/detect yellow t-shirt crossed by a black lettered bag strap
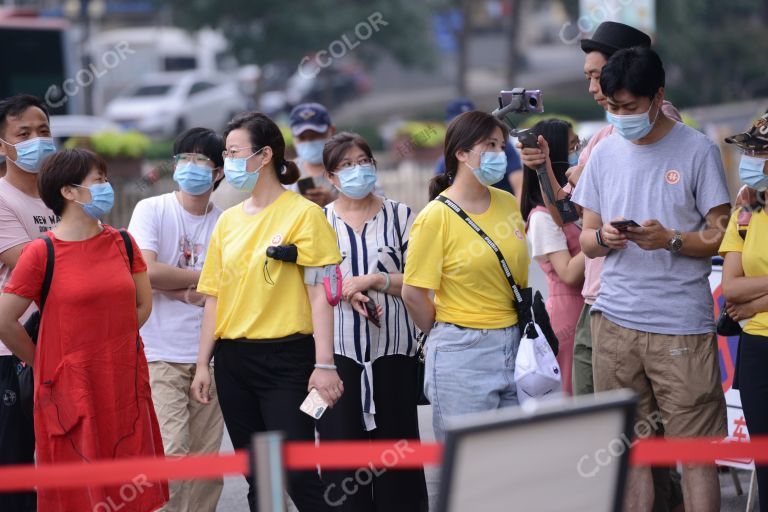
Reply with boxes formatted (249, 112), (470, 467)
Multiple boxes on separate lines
(404, 187), (530, 329)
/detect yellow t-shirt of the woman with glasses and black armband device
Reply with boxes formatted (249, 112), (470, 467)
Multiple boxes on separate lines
(197, 191), (341, 340)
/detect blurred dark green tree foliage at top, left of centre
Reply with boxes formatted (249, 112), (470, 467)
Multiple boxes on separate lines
(156, 0), (433, 66)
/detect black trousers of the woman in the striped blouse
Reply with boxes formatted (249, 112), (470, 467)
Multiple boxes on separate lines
(317, 354), (427, 512)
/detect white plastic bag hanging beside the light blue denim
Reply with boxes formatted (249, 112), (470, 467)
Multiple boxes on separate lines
(515, 323), (563, 404)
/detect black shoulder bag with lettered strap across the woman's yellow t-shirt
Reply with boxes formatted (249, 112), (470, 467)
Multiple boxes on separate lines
(437, 195), (560, 355)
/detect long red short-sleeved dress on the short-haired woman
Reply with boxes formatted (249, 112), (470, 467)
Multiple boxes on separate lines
(4, 225), (168, 512)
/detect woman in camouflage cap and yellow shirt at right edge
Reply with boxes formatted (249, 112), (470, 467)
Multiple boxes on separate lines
(720, 121), (768, 512)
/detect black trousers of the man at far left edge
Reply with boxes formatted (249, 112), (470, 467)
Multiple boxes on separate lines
(0, 356), (37, 512)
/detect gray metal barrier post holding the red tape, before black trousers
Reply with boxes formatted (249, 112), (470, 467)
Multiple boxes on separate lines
(251, 432), (287, 512)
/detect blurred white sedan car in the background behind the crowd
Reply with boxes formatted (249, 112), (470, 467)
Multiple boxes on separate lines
(105, 72), (248, 138)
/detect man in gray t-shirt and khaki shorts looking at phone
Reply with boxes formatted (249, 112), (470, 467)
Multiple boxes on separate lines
(573, 48), (730, 511)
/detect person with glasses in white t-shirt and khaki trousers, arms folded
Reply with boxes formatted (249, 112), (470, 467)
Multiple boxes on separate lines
(129, 128), (224, 512)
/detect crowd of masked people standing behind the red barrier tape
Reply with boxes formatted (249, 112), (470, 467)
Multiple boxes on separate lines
(0, 18), (768, 512)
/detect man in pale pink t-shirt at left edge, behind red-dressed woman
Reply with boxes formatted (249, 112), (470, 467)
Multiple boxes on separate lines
(0, 95), (59, 511)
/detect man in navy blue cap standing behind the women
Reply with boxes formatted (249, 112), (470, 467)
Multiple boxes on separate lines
(286, 103), (338, 206)
